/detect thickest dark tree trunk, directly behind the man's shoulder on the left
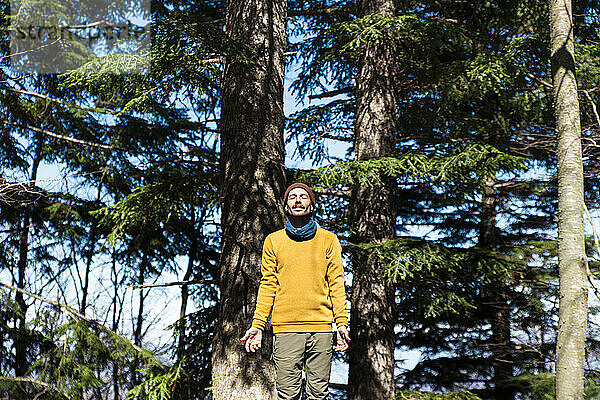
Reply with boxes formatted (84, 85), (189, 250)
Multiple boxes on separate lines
(212, 0), (286, 400)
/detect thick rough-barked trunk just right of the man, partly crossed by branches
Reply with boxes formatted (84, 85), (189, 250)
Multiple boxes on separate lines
(348, 0), (396, 400)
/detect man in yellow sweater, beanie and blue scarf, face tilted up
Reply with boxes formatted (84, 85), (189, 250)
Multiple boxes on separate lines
(241, 183), (350, 400)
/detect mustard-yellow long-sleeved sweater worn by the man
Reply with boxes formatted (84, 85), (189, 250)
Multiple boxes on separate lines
(252, 228), (348, 333)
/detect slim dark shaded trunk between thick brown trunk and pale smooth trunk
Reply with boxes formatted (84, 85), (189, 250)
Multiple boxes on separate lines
(477, 176), (515, 400)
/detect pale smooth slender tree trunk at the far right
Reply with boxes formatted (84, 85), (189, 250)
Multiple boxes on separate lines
(550, 0), (588, 400)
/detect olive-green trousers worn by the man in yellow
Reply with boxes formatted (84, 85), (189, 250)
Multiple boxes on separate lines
(273, 332), (333, 400)
